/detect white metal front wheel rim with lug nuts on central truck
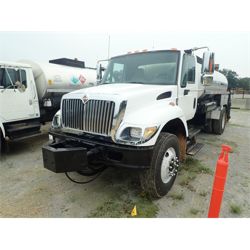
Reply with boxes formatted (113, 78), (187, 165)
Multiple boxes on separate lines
(161, 148), (178, 184)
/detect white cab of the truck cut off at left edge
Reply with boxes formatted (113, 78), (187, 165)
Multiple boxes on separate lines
(0, 62), (40, 146)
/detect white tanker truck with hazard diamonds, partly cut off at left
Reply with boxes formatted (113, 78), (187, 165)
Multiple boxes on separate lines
(0, 58), (96, 152)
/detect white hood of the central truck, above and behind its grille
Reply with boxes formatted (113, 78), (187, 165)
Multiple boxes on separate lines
(63, 83), (177, 128)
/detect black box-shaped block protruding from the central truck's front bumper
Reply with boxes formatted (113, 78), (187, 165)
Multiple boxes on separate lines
(42, 143), (88, 173)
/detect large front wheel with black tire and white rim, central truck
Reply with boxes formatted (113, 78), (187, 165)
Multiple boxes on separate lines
(140, 133), (180, 198)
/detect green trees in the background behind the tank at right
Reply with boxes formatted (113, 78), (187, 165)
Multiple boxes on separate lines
(219, 69), (250, 91)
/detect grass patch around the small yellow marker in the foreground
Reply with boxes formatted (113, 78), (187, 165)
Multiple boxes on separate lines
(89, 196), (158, 218)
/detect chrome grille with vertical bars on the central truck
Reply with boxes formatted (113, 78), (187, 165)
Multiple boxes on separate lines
(62, 99), (115, 135)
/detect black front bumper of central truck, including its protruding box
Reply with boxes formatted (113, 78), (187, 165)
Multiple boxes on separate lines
(42, 131), (153, 173)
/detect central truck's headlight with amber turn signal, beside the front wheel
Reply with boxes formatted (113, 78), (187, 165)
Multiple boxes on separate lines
(120, 126), (158, 144)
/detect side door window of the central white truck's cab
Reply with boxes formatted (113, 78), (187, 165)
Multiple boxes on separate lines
(181, 54), (195, 88)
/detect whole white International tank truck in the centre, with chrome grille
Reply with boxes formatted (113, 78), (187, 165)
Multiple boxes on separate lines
(43, 48), (231, 197)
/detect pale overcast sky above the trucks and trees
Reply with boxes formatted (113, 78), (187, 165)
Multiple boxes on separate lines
(0, 32), (250, 77)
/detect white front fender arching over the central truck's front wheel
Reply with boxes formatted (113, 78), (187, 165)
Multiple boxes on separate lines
(117, 102), (188, 146)
